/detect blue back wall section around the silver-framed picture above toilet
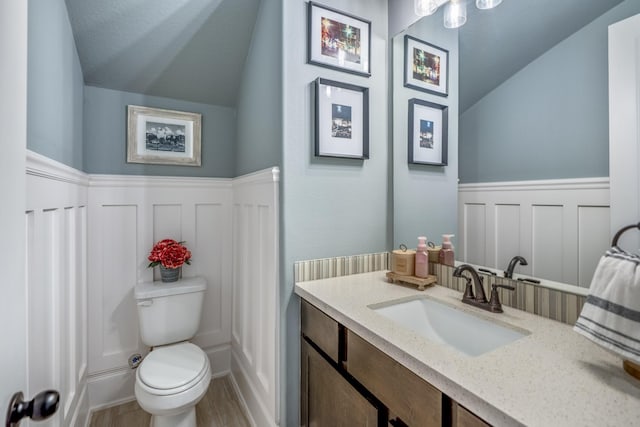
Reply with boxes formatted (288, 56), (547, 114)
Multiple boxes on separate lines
(84, 86), (236, 178)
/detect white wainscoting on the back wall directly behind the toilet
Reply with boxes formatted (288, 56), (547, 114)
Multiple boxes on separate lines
(88, 175), (232, 408)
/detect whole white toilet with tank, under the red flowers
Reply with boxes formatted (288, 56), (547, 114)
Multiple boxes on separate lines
(135, 277), (211, 427)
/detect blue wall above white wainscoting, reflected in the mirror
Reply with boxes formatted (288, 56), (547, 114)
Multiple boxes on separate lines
(459, 0), (640, 183)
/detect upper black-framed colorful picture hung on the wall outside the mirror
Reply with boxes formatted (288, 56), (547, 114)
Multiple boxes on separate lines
(307, 2), (371, 77)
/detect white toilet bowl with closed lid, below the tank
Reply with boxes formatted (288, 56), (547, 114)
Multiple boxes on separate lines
(135, 342), (211, 427)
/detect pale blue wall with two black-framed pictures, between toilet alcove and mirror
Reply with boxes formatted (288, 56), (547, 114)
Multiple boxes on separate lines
(280, 0), (391, 426)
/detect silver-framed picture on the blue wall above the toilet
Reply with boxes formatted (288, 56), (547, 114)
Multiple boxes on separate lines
(127, 105), (202, 166)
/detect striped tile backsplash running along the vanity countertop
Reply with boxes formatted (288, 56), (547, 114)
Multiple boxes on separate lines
(293, 252), (586, 325)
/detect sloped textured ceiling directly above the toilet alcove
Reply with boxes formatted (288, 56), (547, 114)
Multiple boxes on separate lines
(66, 0), (260, 106)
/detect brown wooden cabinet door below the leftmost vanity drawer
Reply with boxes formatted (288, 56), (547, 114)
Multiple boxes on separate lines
(300, 339), (378, 427)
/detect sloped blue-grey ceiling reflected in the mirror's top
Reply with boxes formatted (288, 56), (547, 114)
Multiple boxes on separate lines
(458, 0), (622, 112)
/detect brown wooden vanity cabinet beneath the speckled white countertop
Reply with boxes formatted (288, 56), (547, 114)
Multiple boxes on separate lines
(300, 300), (489, 427)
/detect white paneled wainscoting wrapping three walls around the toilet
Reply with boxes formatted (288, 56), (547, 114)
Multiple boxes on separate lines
(25, 152), (279, 426)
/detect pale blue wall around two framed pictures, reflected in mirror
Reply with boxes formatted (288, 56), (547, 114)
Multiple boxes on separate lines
(392, 12), (459, 248)
